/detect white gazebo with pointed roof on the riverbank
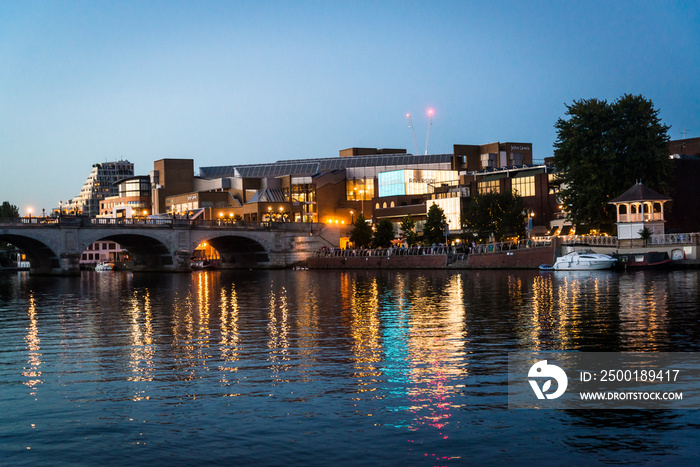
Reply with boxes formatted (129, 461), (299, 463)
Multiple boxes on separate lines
(608, 183), (671, 240)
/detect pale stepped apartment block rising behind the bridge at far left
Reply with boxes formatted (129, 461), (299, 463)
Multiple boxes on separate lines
(61, 160), (134, 217)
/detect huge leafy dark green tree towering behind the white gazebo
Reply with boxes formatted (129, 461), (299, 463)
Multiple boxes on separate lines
(554, 94), (671, 231)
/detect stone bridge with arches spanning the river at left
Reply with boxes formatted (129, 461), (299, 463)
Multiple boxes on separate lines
(0, 217), (337, 275)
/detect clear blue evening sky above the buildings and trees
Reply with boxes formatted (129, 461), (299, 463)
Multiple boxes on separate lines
(0, 0), (700, 214)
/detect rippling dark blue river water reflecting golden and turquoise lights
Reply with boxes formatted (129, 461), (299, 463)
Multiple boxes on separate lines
(0, 271), (700, 465)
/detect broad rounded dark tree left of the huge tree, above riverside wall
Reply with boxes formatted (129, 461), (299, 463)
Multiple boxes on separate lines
(462, 191), (526, 241)
